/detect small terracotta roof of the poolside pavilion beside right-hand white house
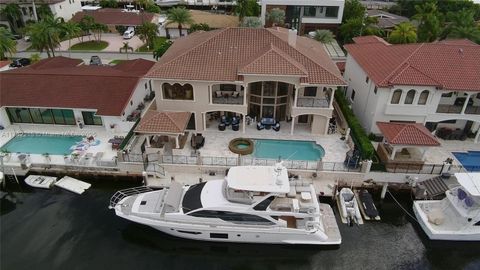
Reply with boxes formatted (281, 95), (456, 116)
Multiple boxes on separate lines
(377, 122), (440, 146)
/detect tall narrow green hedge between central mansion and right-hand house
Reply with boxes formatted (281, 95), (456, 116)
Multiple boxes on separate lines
(335, 91), (375, 159)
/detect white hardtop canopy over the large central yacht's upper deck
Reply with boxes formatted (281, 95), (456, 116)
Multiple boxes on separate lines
(226, 164), (290, 193)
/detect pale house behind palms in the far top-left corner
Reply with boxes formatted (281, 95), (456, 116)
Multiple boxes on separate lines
(0, 0), (82, 22)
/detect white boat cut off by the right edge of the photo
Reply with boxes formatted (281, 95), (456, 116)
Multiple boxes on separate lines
(413, 173), (480, 241)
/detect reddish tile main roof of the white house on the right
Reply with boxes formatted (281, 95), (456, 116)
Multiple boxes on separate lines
(345, 37), (480, 91)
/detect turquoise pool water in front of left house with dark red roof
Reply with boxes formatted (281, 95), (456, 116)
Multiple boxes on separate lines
(0, 134), (83, 155)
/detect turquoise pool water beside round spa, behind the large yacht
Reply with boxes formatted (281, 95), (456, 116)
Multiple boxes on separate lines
(253, 139), (325, 160)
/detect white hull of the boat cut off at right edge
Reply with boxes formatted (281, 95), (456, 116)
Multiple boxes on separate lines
(413, 201), (480, 241)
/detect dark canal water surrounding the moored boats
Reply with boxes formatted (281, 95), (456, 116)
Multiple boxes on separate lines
(0, 179), (480, 270)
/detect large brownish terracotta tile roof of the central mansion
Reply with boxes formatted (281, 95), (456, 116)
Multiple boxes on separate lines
(147, 28), (346, 85)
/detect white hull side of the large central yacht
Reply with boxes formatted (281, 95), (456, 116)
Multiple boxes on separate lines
(115, 206), (341, 245)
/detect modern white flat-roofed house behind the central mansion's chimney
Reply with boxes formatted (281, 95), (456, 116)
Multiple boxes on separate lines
(260, 0), (345, 35)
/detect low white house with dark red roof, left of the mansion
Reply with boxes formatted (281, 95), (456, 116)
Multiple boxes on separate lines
(0, 57), (154, 132)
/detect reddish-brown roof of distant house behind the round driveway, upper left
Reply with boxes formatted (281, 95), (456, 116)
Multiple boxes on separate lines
(71, 8), (155, 26)
